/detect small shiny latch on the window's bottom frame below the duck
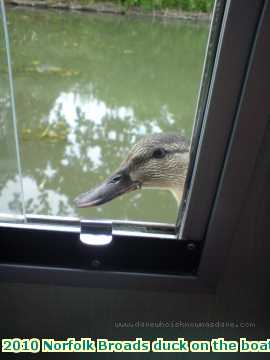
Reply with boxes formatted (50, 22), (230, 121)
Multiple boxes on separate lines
(80, 220), (112, 246)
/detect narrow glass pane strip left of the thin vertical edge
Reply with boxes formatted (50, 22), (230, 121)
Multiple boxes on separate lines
(0, 2), (23, 220)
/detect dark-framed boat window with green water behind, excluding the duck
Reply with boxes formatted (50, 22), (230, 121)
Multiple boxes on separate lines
(0, 0), (270, 290)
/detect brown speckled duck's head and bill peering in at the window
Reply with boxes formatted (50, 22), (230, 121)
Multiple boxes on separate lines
(74, 133), (190, 208)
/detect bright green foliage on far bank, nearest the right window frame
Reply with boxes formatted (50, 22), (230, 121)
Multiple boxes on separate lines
(120, 0), (214, 12)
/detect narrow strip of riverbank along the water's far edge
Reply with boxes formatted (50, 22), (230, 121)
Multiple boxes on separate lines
(5, 0), (211, 21)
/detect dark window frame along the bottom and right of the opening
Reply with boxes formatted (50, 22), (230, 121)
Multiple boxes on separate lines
(0, 0), (270, 292)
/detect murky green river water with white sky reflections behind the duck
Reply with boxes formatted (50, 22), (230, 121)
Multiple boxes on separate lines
(0, 9), (209, 223)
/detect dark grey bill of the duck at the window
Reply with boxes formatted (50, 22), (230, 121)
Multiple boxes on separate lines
(74, 174), (140, 208)
